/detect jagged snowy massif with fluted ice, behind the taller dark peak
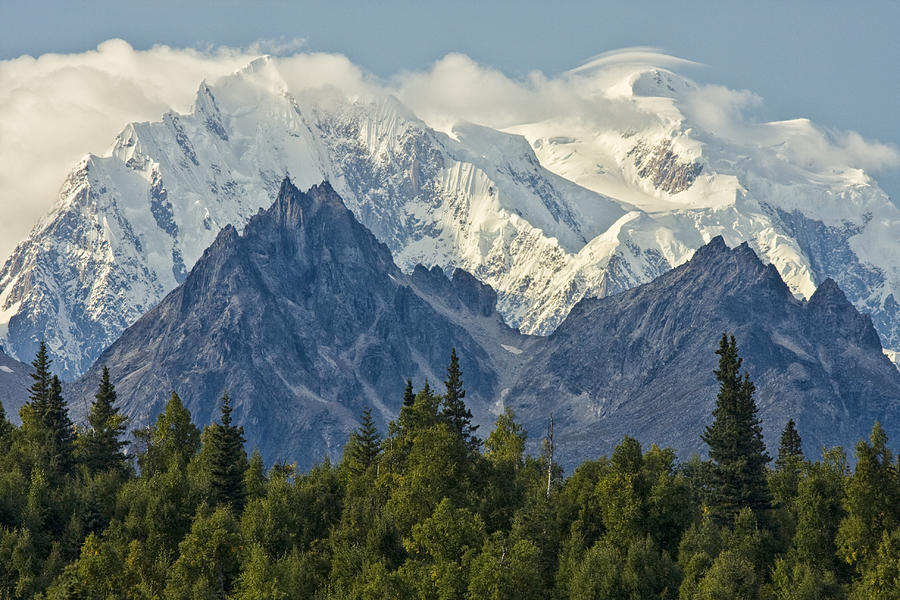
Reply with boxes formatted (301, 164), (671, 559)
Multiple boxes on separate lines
(0, 59), (626, 380)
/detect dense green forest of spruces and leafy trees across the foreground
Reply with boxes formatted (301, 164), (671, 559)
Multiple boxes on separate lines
(0, 335), (900, 600)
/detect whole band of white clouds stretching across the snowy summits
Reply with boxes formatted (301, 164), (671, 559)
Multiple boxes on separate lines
(0, 40), (900, 257)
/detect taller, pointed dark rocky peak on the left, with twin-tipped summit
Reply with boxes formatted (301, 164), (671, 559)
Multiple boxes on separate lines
(70, 181), (517, 466)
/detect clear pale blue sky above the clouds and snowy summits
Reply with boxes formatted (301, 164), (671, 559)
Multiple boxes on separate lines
(0, 0), (900, 201)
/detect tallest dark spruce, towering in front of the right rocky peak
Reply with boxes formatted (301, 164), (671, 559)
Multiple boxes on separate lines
(702, 333), (771, 524)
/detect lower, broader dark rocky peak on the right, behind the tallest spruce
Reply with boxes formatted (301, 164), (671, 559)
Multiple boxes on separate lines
(507, 238), (900, 462)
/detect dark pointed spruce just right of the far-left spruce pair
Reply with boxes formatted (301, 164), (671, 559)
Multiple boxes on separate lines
(78, 367), (127, 473)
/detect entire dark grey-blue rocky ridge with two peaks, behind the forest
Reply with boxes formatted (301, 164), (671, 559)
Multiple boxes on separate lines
(69, 180), (900, 466)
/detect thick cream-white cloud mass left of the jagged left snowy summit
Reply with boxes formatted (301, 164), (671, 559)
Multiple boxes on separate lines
(0, 40), (268, 256)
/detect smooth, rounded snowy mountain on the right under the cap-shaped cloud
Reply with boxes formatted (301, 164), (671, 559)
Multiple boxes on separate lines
(509, 65), (900, 348)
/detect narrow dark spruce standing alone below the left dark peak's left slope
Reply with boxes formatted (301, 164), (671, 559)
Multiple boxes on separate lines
(210, 393), (247, 513)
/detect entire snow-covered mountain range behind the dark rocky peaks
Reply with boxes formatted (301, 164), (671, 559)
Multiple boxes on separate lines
(0, 58), (900, 378)
